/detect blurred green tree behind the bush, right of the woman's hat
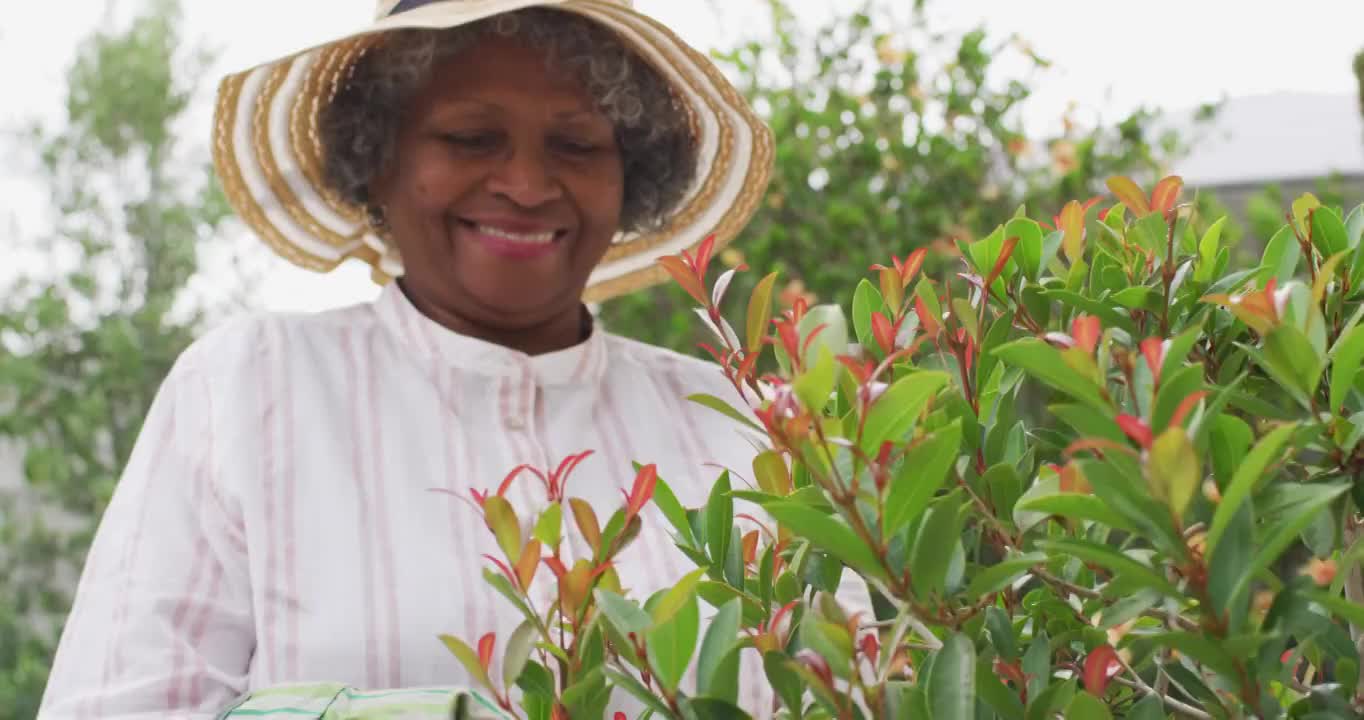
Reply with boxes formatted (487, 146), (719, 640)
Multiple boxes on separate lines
(603, 0), (1211, 352)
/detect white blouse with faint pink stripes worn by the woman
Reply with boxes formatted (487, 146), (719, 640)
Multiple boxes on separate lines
(41, 285), (780, 719)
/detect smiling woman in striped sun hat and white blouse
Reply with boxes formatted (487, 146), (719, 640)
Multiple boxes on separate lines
(42, 0), (771, 719)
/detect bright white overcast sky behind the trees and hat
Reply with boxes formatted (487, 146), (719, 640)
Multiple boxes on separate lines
(0, 0), (1364, 308)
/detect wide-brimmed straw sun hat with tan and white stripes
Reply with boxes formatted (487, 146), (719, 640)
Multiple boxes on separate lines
(213, 0), (772, 301)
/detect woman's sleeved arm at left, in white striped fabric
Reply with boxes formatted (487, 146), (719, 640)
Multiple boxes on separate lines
(40, 349), (254, 720)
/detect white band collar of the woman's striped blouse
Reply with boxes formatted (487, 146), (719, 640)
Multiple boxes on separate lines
(375, 282), (607, 386)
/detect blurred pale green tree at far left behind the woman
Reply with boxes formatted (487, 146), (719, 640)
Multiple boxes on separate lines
(0, 0), (228, 720)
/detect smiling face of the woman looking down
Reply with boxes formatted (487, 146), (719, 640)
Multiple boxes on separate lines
(371, 38), (623, 340)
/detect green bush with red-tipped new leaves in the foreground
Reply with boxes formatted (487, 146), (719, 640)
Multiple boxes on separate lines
(446, 177), (1364, 720)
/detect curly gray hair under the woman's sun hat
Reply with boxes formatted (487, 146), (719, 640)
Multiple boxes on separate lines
(319, 8), (697, 232)
